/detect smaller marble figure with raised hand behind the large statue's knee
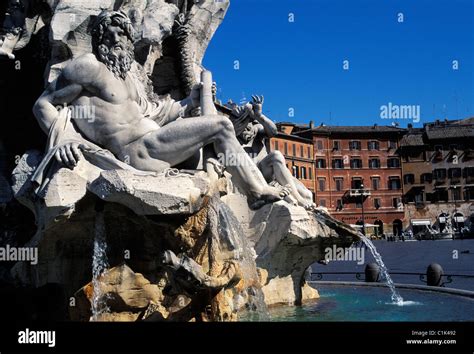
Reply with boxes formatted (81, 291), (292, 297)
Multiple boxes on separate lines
(230, 95), (315, 210)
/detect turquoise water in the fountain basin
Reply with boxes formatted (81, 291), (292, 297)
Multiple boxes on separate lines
(262, 285), (474, 322)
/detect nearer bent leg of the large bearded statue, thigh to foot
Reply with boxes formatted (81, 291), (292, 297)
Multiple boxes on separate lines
(127, 116), (287, 201)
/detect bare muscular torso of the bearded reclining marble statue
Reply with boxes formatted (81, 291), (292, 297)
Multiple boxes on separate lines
(71, 59), (159, 154)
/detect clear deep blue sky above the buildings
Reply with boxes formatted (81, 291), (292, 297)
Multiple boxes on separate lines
(204, 0), (474, 126)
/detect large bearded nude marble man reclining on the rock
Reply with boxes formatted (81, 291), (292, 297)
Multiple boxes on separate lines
(33, 11), (289, 202)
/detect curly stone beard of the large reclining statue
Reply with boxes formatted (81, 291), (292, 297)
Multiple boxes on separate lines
(97, 44), (135, 79)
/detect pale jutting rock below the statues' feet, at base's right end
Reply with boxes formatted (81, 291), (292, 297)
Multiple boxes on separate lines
(239, 202), (355, 305)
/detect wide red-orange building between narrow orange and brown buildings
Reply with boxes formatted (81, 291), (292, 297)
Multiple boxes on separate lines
(292, 125), (405, 234)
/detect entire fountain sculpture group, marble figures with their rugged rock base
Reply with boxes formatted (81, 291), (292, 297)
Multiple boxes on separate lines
(0, 0), (358, 321)
